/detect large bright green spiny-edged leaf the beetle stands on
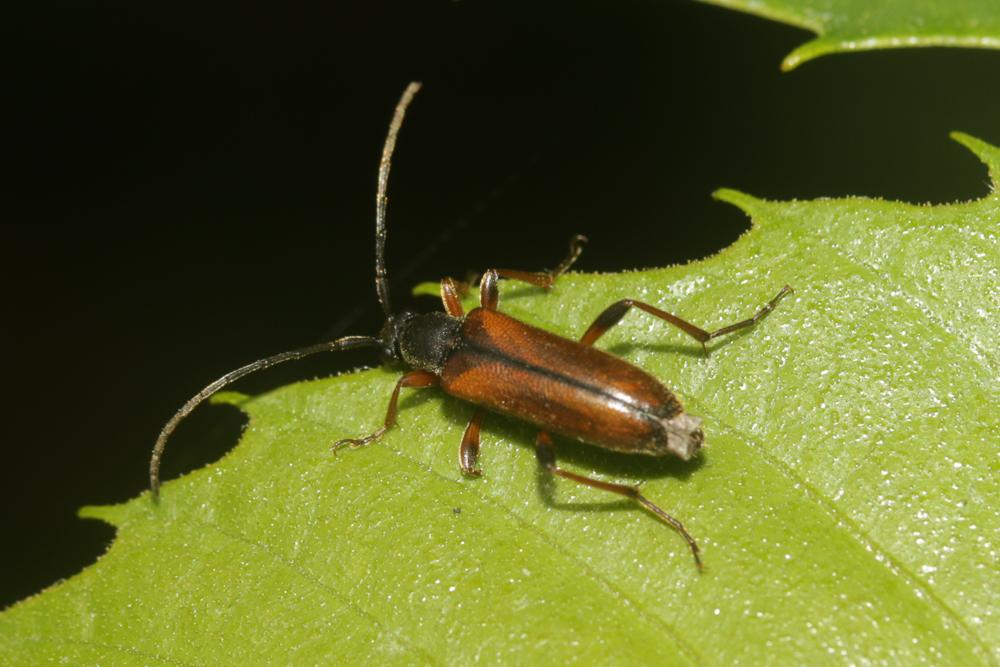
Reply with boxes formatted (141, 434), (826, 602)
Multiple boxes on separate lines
(0, 135), (1000, 665)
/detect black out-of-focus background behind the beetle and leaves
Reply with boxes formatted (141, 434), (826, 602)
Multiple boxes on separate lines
(0, 0), (1000, 606)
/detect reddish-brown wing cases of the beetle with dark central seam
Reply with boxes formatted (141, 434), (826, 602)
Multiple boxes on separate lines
(441, 308), (700, 458)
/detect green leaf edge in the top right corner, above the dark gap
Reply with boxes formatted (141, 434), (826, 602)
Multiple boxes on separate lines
(701, 0), (1000, 70)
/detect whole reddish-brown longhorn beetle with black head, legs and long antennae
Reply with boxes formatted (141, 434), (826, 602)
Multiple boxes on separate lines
(149, 83), (792, 569)
